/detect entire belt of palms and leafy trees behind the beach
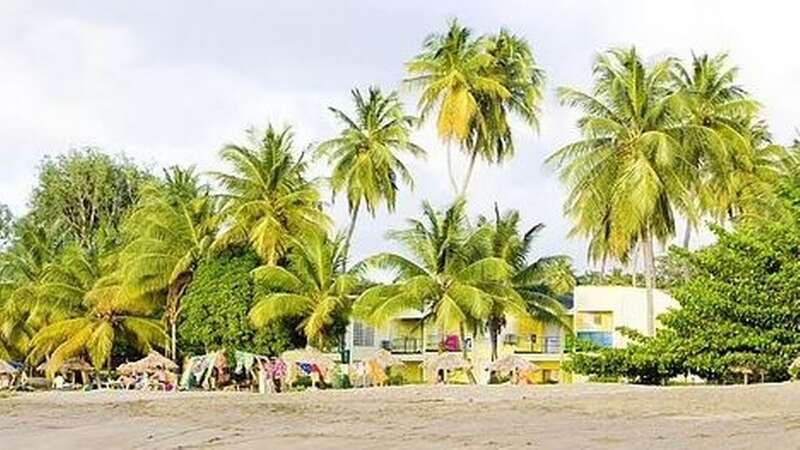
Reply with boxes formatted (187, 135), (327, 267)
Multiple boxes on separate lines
(0, 21), (800, 382)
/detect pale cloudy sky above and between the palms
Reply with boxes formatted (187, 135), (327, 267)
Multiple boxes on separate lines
(0, 0), (800, 268)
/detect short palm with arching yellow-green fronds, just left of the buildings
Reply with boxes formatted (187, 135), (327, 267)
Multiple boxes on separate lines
(250, 233), (358, 347)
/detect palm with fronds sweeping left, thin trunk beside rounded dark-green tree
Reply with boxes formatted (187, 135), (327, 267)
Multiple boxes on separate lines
(121, 168), (219, 359)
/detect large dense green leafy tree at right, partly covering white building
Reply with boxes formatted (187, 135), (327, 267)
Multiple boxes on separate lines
(571, 188), (800, 383)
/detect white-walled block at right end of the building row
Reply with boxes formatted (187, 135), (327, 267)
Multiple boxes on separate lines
(570, 286), (679, 348)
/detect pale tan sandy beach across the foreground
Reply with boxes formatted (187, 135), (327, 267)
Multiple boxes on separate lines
(0, 383), (800, 450)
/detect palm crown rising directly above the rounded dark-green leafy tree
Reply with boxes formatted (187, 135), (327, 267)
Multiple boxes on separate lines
(213, 125), (330, 265)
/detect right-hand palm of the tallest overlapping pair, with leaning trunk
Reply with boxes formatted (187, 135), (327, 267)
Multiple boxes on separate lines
(461, 29), (544, 196)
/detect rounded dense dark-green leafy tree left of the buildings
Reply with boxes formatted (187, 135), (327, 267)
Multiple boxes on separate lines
(178, 250), (305, 355)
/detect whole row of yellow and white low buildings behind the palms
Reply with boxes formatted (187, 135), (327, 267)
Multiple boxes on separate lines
(346, 286), (678, 383)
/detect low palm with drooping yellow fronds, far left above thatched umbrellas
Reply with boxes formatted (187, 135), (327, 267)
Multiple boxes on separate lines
(28, 276), (168, 376)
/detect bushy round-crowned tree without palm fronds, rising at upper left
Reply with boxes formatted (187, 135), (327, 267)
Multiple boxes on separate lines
(30, 148), (152, 249)
